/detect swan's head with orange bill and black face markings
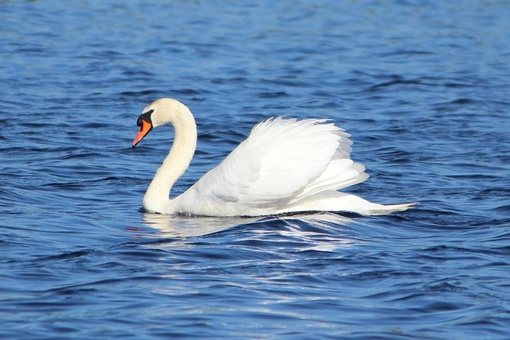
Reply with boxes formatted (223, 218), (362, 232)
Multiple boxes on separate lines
(133, 98), (194, 147)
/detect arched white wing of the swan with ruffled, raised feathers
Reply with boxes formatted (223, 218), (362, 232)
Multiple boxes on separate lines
(175, 117), (368, 215)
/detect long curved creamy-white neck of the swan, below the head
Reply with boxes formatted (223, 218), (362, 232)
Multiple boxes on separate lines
(143, 113), (197, 213)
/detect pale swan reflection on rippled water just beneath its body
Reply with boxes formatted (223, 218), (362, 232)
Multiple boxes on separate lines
(142, 213), (353, 237)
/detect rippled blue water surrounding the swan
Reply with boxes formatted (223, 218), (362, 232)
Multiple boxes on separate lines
(0, 0), (510, 339)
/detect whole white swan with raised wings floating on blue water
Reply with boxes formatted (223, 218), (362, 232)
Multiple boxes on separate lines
(133, 98), (413, 216)
